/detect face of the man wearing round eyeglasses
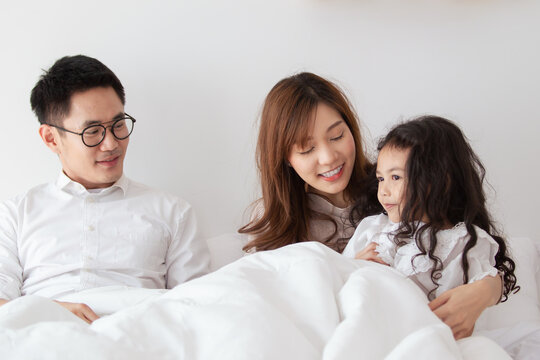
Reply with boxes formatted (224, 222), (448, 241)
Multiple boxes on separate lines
(50, 87), (129, 189)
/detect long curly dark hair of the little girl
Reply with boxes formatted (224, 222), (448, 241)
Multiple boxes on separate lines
(378, 116), (519, 301)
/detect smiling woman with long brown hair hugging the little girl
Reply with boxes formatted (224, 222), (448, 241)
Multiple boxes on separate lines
(239, 73), (502, 339)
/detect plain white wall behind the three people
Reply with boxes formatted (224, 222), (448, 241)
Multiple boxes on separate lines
(0, 0), (540, 239)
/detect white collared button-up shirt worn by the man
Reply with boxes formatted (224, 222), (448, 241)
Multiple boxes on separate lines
(0, 173), (209, 300)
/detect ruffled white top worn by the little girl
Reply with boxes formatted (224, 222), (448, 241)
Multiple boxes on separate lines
(343, 214), (499, 297)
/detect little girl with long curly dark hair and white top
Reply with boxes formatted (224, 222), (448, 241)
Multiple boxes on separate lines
(343, 116), (519, 301)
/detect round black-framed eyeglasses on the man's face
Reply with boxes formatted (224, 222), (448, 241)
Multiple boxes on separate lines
(47, 114), (136, 147)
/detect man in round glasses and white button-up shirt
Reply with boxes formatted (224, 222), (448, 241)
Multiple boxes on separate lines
(0, 55), (209, 323)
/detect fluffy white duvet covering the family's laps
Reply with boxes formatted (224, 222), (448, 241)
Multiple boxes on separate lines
(0, 243), (509, 360)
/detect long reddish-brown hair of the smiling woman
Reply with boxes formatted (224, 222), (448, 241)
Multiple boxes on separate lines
(238, 72), (380, 251)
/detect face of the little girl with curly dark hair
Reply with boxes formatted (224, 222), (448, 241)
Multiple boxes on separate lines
(377, 146), (411, 223)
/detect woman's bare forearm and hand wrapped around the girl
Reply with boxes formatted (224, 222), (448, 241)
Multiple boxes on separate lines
(429, 275), (503, 340)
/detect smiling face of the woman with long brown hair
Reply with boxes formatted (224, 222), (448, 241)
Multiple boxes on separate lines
(288, 103), (356, 207)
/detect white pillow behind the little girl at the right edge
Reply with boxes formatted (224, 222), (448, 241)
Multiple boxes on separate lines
(475, 238), (540, 331)
